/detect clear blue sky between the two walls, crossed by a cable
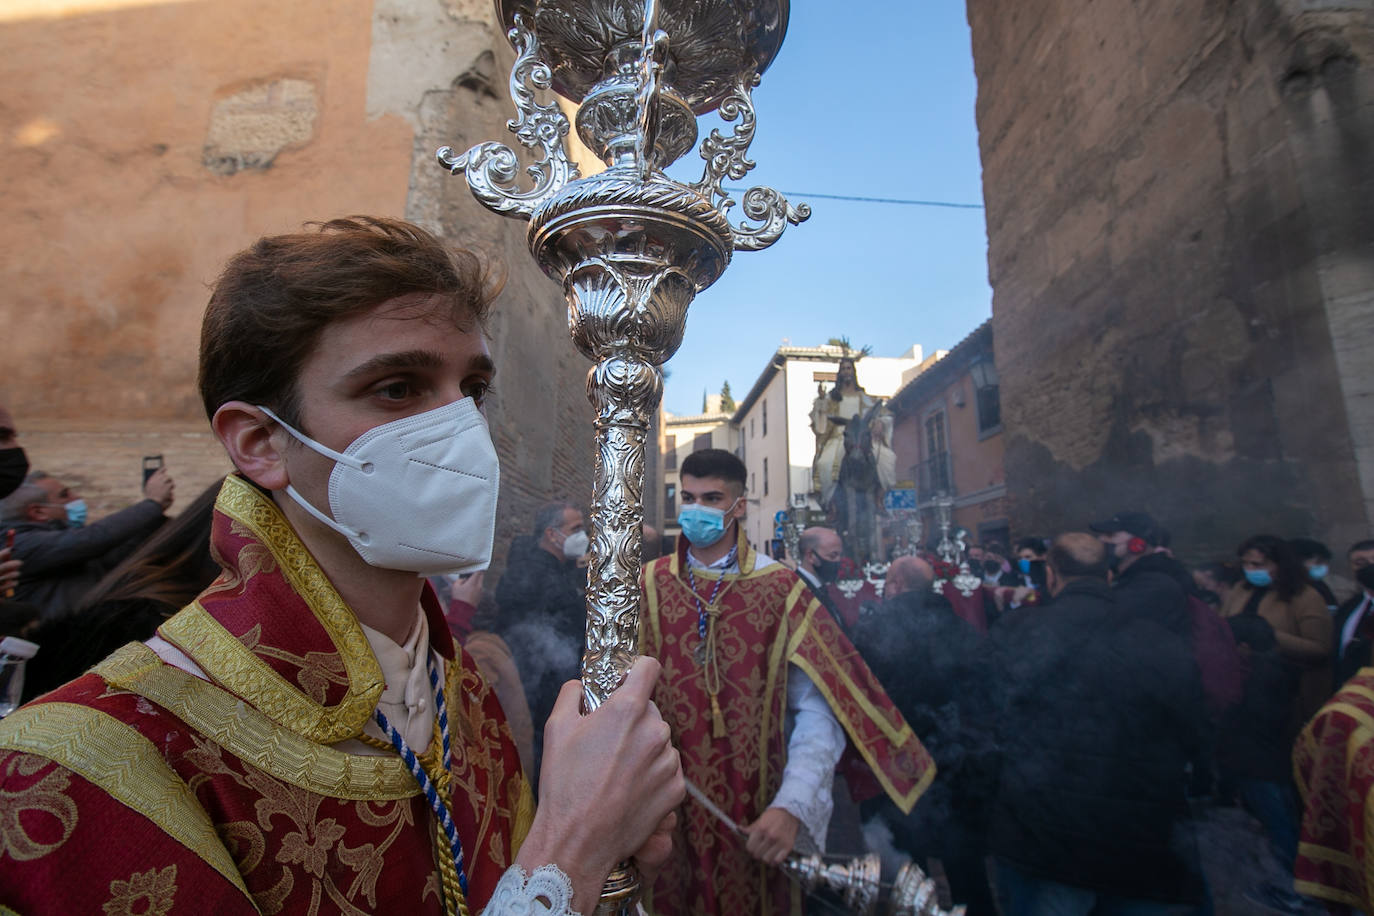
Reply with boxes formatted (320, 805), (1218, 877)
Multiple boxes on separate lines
(664, 0), (992, 413)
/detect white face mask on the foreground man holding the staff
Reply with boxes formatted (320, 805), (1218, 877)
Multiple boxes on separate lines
(258, 398), (500, 575)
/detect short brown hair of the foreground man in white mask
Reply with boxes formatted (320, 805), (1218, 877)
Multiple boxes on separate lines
(199, 216), (502, 424)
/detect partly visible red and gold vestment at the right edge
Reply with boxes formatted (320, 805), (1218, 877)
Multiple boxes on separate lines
(1293, 667), (1374, 912)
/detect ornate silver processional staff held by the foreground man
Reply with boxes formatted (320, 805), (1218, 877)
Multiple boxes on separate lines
(438, 0), (811, 915)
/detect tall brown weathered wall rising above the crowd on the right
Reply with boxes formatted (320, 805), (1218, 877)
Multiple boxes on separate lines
(969, 0), (1374, 558)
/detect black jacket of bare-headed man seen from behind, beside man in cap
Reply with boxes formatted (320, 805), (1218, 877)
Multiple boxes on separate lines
(989, 580), (1204, 902)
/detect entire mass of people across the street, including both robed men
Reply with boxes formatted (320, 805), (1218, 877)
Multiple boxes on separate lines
(0, 218), (1374, 916)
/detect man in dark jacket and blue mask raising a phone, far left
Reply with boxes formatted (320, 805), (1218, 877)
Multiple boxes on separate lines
(0, 468), (174, 619)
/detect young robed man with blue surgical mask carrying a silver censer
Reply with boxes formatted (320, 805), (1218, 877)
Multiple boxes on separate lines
(640, 449), (934, 916)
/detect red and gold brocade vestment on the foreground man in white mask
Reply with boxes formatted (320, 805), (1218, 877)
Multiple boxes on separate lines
(0, 477), (533, 916)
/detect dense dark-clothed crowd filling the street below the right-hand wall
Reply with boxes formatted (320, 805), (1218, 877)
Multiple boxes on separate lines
(801, 511), (1374, 916)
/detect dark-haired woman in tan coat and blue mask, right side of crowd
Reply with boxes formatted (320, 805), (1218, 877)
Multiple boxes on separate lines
(1221, 534), (1334, 737)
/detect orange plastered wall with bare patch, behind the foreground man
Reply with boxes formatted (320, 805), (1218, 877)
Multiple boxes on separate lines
(0, 0), (658, 567)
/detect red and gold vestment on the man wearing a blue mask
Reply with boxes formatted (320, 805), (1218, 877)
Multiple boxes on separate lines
(640, 537), (934, 916)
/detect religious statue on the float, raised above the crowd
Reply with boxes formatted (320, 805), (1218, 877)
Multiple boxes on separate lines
(811, 339), (897, 564)
